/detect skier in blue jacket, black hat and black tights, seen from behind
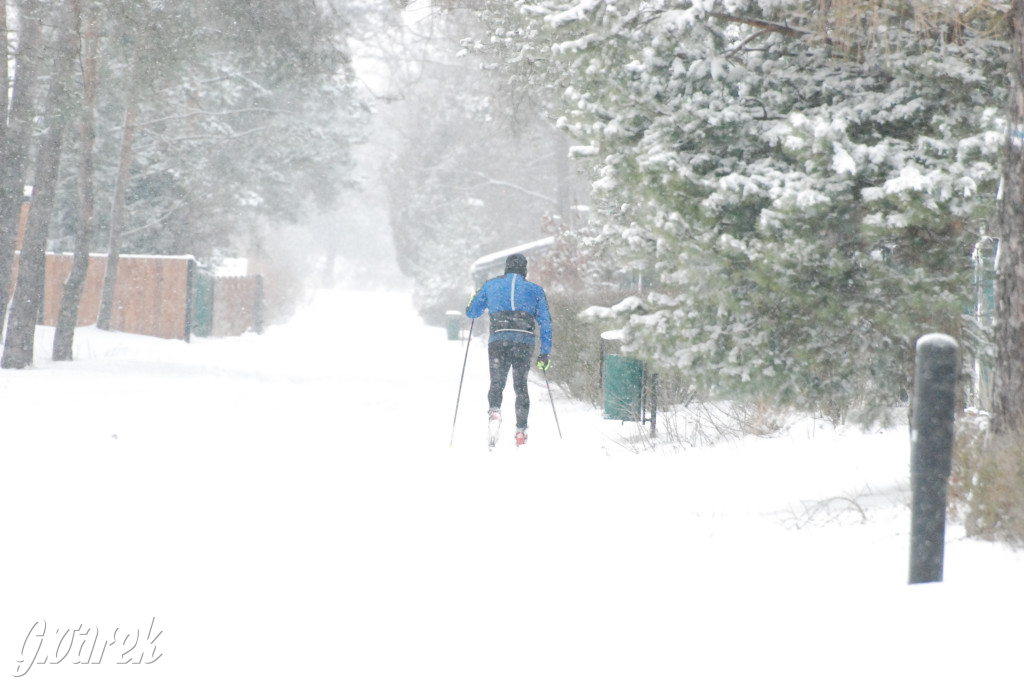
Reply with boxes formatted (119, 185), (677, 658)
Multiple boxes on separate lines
(466, 253), (551, 447)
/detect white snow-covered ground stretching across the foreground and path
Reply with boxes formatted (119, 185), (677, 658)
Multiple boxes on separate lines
(0, 291), (1024, 687)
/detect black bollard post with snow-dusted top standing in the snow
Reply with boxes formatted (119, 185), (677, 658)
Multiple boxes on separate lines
(910, 334), (958, 585)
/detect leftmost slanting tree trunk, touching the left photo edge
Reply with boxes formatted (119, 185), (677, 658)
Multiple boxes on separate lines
(0, 2), (42, 341)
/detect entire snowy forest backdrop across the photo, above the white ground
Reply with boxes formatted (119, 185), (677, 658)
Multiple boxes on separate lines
(0, 0), (1024, 536)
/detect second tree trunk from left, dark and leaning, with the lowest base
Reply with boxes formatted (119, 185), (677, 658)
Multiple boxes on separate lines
(0, 0), (78, 369)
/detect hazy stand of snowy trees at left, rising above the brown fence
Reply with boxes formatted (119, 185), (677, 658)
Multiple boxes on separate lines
(0, 0), (367, 368)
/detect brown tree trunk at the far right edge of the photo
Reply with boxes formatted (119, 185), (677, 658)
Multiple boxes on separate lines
(992, 0), (1024, 433)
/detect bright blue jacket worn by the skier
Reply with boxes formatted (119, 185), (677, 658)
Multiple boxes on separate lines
(466, 272), (551, 354)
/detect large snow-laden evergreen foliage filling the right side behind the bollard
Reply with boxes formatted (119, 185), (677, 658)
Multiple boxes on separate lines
(475, 0), (1007, 422)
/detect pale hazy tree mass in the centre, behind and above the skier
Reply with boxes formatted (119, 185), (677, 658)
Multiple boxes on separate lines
(377, 3), (587, 324)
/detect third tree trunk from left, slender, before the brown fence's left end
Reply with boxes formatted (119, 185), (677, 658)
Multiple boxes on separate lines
(53, 5), (96, 360)
